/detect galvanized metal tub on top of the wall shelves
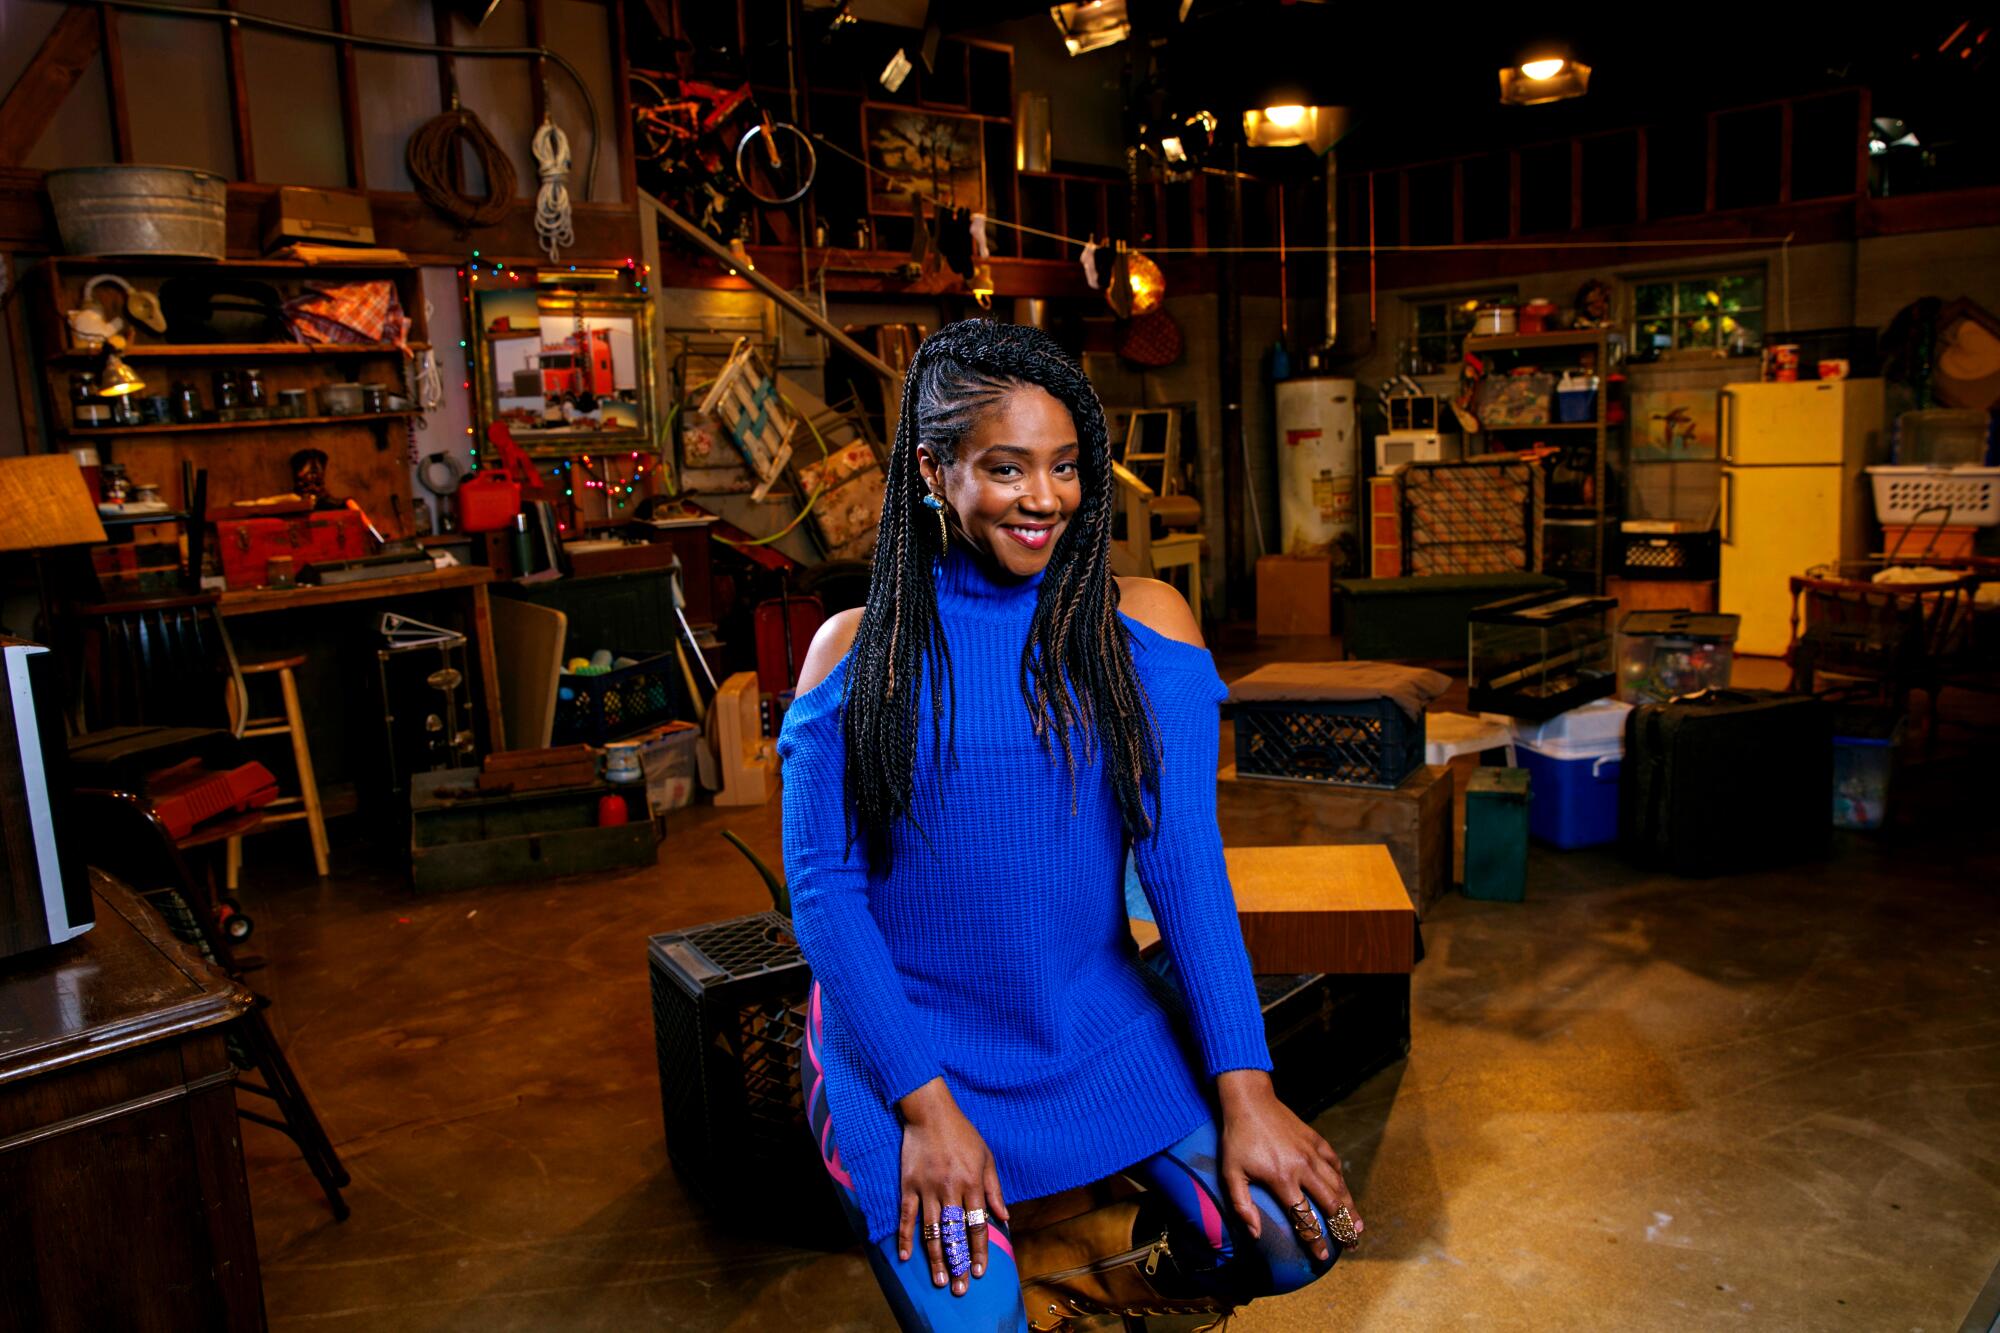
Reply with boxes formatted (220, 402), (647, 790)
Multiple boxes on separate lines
(48, 166), (228, 260)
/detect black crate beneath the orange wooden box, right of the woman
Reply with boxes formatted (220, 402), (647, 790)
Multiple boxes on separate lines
(1144, 949), (1410, 1121)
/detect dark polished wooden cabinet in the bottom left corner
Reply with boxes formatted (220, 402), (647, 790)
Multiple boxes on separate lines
(0, 871), (266, 1333)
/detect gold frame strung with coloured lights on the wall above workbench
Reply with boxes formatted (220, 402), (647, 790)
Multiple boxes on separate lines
(472, 288), (660, 458)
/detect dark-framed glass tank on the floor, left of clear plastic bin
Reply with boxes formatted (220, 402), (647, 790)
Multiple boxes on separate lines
(1468, 592), (1618, 721)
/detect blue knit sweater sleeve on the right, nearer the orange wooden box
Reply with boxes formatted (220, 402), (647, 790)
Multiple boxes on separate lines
(1132, 640), (1270, 1077)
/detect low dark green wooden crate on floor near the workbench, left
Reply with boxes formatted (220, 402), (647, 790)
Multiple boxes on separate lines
(410, 769), (660, 891)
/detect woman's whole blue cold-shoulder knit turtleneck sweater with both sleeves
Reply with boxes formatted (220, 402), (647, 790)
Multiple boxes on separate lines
(778, 548), (1270, 1243)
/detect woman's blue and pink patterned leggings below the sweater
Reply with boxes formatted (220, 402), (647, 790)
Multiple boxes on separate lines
(804, 983), (1340, 1333)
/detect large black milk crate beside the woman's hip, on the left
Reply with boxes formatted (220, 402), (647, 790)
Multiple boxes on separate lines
(646, 913), (850, 1249)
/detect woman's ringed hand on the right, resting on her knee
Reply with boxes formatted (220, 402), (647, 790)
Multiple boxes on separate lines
(1216, 1069), (1362, 1259)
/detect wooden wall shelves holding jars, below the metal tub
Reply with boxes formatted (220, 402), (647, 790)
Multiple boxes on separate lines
(26, 256), (430, 536)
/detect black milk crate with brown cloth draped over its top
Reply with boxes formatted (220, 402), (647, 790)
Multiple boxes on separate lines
(1228, 699), (1424, 789)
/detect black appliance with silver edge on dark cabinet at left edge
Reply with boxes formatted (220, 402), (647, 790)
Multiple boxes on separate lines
(0, 636), (96, 957)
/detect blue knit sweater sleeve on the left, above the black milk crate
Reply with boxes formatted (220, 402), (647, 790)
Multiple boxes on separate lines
(778, 675), (944, 1103)
